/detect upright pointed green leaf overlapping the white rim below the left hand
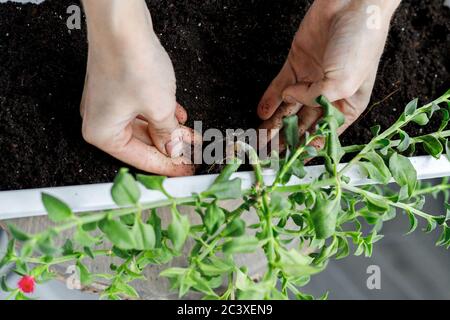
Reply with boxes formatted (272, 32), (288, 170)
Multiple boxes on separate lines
(111, 169), (141, 206)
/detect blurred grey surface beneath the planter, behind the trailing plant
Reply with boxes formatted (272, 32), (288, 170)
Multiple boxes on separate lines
(0, 180), (450, 299)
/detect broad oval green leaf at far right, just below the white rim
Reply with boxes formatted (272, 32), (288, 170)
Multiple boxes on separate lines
(389, 153), (417, 197)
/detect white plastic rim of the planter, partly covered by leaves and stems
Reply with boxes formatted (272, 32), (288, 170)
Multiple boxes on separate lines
(0, 156), (450, 220)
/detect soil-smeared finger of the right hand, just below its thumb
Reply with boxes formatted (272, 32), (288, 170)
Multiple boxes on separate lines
(259, 103), (302, 146)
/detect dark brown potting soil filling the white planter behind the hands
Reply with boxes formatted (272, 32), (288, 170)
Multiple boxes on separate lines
(0, 0), (450, 190)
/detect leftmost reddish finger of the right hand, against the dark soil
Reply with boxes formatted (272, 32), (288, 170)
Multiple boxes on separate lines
(258, 61), (296, 120)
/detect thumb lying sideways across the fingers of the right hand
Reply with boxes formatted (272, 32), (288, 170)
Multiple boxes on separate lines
(283, 80), (345, 107)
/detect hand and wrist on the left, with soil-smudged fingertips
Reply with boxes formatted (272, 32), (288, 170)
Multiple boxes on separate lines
(81, 0), (194, 176)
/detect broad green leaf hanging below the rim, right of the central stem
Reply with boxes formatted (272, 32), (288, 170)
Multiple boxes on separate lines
(311, 194), (341, 239)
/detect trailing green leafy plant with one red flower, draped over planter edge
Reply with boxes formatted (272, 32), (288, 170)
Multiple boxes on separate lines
(0, 91), (450, 300)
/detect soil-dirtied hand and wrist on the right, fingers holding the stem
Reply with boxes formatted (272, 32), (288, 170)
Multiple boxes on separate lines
(258, 0), (400, 148)
